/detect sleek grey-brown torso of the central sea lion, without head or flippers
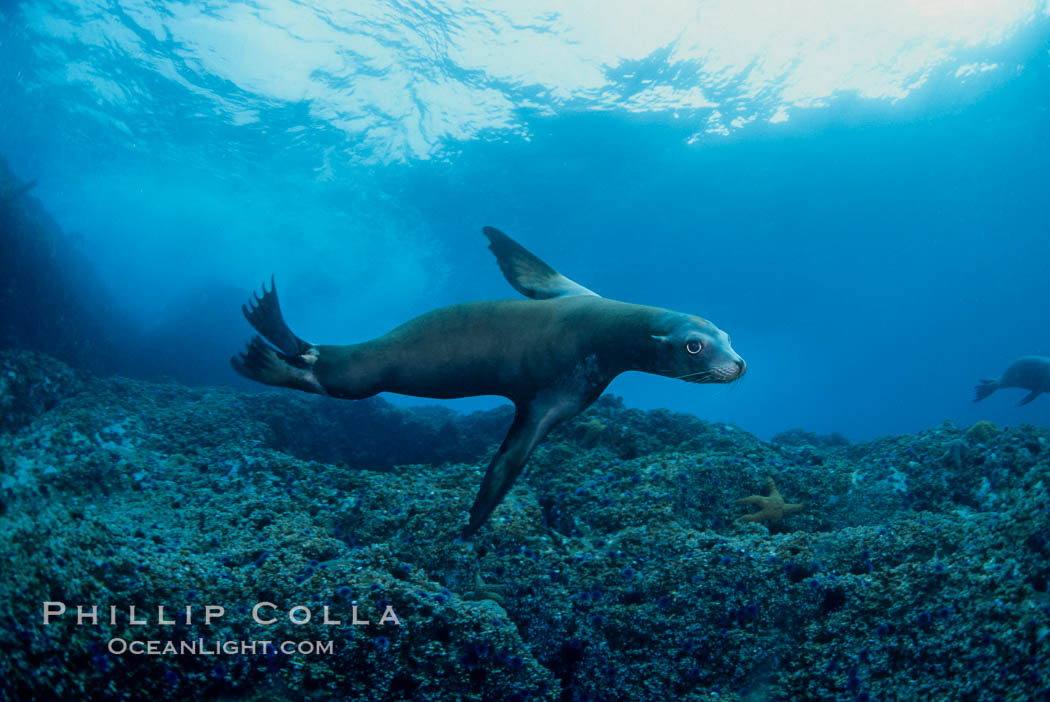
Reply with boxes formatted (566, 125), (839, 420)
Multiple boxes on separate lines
(314, 296), (688, 403)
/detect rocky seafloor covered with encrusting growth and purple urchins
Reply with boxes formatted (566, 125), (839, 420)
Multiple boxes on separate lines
(0, 352), (1050, 701)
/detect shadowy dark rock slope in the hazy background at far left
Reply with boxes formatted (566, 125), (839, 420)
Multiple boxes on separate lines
(0, 158), (256, 385)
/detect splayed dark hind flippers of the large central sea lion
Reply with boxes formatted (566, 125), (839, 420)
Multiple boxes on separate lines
(230, 277), (327, 395)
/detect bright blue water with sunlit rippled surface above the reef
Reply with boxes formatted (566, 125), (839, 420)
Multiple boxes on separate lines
(0, 0), (1050, 439)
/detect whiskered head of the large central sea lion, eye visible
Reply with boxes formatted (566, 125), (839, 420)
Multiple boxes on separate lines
(650, 313), (748, 383)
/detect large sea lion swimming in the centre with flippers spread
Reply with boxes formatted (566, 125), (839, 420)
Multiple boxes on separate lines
(231, 227), (747, 536)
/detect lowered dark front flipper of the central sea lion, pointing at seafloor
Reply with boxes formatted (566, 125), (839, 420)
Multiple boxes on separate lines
(462, 394), (579, 538)
